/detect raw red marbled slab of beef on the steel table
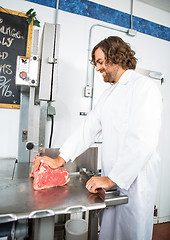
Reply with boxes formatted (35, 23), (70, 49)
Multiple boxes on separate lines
(30, 163), (70, 190)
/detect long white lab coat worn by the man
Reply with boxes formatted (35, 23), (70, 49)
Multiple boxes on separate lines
(60, 70), (162, 240)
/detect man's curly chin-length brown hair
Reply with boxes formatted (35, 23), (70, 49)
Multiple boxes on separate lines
(91, 36), (137, 70)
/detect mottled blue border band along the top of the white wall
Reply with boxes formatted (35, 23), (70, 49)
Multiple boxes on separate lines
(26, 0), (170, 41)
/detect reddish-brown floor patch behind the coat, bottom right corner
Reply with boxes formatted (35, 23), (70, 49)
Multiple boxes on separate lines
(152, 222), (170, 240)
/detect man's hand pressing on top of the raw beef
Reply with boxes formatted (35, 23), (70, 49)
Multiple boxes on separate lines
(33, 156), (66, 171)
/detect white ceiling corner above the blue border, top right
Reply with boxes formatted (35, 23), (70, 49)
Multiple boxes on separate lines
(138, 0), (170, 12)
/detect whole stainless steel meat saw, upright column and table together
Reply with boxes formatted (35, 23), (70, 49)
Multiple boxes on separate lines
(0, 23), (128, 240)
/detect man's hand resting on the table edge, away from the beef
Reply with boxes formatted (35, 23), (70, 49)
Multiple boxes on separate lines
(86, 177), (116, 193)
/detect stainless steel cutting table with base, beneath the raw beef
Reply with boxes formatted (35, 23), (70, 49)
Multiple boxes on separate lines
(0, 156), (128, 240)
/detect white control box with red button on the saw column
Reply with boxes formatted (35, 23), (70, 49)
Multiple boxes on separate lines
(15, 55), (39, 86)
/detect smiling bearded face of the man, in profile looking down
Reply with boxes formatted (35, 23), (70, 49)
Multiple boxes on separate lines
(95, 48), (119, 83)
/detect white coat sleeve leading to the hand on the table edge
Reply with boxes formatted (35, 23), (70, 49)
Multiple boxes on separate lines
(108, 78), (162, 190)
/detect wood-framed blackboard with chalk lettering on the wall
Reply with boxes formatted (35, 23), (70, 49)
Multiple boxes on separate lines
(0, 7), (32, 108)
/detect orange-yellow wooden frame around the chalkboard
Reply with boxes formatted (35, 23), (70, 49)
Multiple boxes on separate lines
(0, 7), (33, 109)
